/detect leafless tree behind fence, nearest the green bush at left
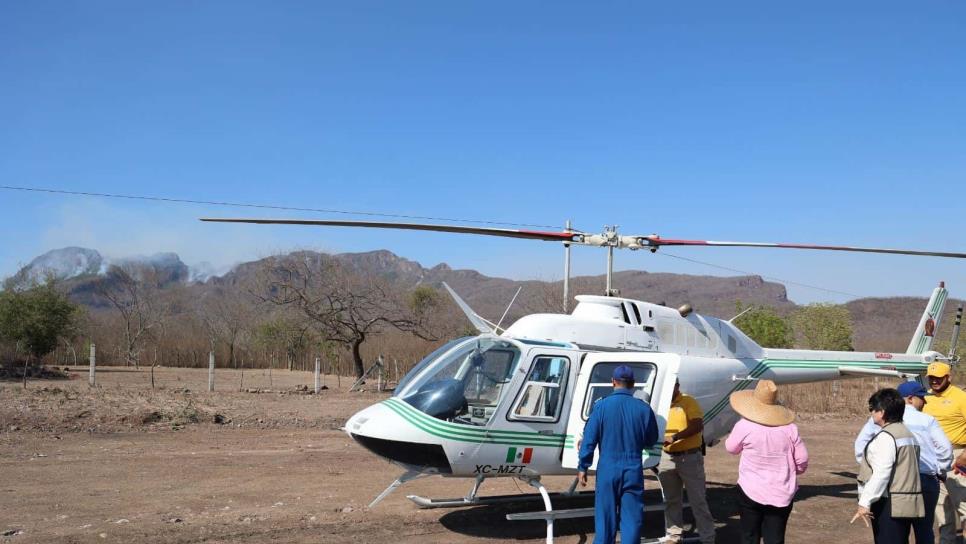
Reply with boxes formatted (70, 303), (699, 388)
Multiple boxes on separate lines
(94, 265), (168, 368)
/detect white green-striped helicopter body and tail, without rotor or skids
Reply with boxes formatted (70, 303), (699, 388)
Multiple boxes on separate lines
(345, 288), (946, 478)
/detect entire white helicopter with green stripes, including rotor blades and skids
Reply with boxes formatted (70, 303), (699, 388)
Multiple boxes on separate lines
(202, 218), (966, 542)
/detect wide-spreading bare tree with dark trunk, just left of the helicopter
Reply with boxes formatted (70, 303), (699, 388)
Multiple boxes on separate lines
(261, 252), (436, 376)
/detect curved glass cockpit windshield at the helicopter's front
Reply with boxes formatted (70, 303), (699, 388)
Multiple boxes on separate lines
(396, 336), (520, 425)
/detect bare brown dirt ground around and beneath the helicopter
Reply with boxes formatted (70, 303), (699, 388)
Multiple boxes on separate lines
(0, 368), (896, 544)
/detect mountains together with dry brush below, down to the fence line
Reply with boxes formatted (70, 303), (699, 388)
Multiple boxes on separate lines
(3, 248), (957, 375)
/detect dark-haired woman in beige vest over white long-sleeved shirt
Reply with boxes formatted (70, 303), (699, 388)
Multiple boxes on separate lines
(851, 389), (926, 544)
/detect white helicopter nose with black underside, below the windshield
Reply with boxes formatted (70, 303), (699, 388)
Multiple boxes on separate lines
(345, 403), (453, 474)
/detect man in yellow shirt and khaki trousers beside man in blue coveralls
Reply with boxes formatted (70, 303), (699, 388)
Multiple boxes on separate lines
(658, 383), (714, 544)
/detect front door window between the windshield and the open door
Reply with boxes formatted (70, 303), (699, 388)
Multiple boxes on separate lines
(510, 357), (570, 421)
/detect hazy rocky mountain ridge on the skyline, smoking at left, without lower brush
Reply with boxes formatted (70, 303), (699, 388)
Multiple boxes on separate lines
(10, 247), (955, 351)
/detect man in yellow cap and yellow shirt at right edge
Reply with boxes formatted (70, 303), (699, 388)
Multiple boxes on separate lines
(922, 363), (966, 544)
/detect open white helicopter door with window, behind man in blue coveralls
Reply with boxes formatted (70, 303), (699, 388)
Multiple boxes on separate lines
(562, 353), (681, 470)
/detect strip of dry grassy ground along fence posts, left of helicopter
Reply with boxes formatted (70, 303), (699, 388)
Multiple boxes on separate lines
(0, 367), (386, 433)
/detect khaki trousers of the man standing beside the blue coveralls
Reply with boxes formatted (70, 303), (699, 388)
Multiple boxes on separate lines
(658, 450), (714, 544)
